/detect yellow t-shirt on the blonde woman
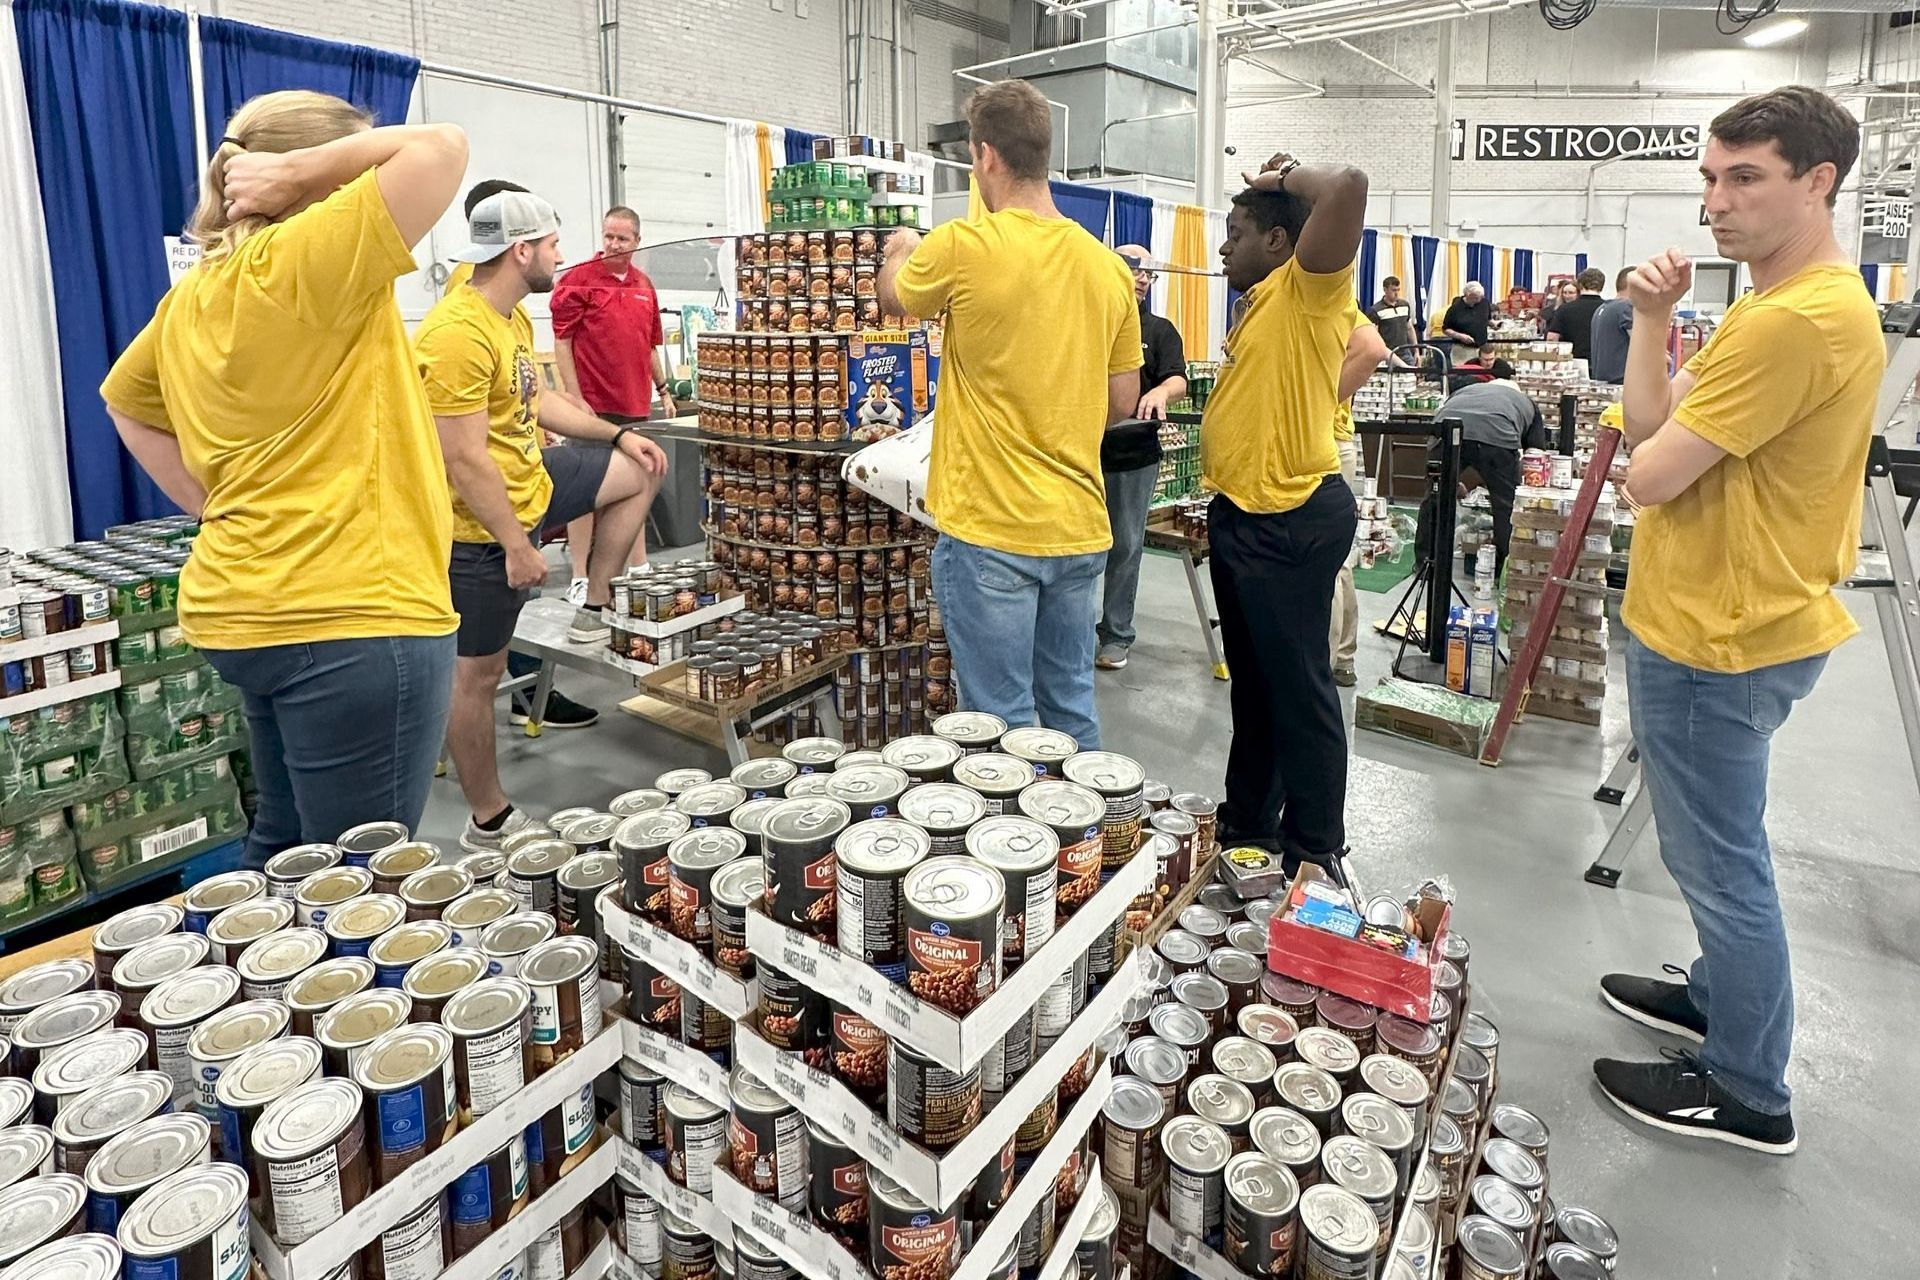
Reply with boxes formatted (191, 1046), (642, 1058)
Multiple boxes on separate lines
(100, 171), (459, 649)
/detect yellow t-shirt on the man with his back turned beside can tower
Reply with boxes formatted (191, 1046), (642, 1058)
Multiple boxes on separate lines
(895, 209), (1140, 557)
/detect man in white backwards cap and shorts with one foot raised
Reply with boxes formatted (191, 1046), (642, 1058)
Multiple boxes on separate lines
(413, 192), (666, 852)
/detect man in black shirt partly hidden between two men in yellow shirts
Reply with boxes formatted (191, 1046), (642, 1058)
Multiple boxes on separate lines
(1092, 244), (1187, 672)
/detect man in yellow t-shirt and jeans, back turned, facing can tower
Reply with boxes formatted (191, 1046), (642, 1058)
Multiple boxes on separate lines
(879, 81), (1136, 750)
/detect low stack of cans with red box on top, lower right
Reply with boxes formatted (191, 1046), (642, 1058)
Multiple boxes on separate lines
(1098, 887), (1617, 1280)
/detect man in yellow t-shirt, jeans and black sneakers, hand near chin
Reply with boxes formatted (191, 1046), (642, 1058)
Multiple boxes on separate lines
(1594, 86), (1885, 1155)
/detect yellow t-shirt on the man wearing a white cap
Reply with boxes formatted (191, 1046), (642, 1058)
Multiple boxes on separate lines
(413, 284), (553, 543)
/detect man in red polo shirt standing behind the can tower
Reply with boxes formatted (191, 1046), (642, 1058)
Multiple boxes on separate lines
(551, 205), (676, 599)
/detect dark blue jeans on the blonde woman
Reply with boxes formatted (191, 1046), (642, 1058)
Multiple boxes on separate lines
(205, 635), (453, 867)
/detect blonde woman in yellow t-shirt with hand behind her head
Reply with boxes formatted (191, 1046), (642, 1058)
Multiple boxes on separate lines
(100, 90), (467, 865)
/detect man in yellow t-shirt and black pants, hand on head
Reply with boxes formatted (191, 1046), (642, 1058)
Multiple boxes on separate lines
(1200, 154), (1367, 871)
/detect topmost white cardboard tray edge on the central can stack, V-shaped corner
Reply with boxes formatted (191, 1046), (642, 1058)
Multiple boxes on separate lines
(747, 844), (1158, 1071)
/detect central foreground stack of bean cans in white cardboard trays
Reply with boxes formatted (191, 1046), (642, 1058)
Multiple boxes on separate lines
(611, 725), (1212, 1280)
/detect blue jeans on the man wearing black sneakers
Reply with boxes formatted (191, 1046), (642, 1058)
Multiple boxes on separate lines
(1626, 633), (1826, 1115)
